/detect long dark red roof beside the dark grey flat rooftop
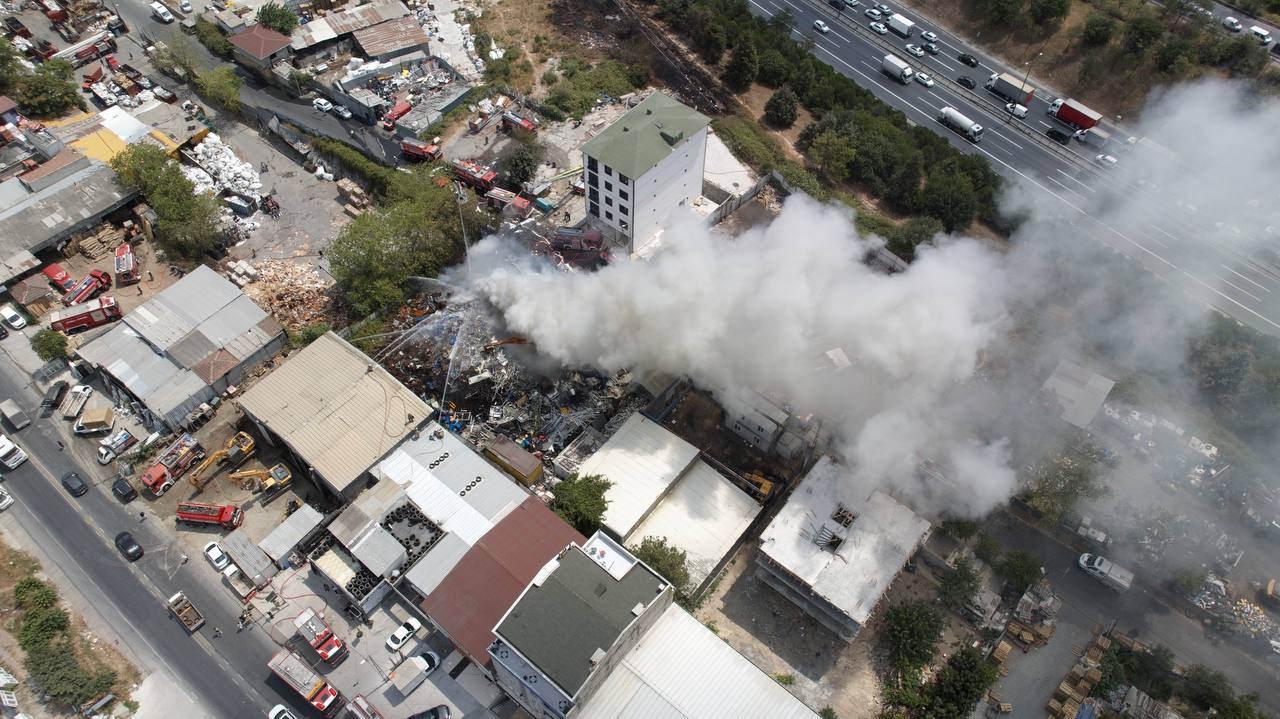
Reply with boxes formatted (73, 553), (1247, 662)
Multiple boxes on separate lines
(421, 496), (586, 665)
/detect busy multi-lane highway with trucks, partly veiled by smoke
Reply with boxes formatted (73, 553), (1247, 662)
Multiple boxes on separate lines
(750, 0), (1280, 336)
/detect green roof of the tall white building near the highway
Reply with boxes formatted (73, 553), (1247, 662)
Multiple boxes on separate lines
(582, 92), (710, 180)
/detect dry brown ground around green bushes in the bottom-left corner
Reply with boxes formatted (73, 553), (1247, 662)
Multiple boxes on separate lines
(0, 540), (141, 719)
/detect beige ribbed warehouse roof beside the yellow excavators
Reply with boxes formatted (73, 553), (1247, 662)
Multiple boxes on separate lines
(232, 333), (431, 491)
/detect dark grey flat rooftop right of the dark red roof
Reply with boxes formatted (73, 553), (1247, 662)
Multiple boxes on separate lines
(495, 545), (667, 697)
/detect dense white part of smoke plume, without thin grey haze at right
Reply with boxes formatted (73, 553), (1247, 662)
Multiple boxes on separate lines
(471, 197), (1014, 514)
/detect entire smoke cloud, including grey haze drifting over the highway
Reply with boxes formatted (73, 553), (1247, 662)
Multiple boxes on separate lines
(460, 78), (1280, 516)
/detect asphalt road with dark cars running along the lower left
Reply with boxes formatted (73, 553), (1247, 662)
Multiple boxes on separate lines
(0, 363), (317, 719)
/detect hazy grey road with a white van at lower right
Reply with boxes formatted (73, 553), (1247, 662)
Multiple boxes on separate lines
(987, 513), (1280, 715)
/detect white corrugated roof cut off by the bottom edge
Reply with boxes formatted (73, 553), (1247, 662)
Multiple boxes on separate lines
(577, 604), (817, 719)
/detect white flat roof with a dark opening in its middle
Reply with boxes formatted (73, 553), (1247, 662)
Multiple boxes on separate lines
(760, 457), (929, 624)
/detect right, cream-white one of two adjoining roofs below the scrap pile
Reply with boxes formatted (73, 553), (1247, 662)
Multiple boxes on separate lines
(625, 459), (760, 586)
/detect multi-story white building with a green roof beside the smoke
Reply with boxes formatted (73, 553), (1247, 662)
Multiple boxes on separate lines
(582, 92), (710, 252)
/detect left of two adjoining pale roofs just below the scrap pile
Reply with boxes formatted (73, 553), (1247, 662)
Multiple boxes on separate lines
(579, 412), (698, 537)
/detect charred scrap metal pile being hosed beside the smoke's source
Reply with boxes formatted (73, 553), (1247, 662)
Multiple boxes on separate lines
(375, 294), (652, 472)
